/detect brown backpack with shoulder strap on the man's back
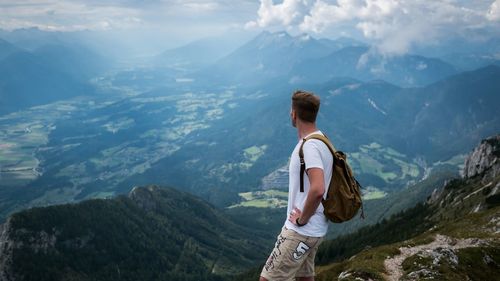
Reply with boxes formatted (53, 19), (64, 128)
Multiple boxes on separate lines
(299, 134), (364, 223)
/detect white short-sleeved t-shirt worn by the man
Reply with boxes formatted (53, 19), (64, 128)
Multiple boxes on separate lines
(285, 131), (333, 237)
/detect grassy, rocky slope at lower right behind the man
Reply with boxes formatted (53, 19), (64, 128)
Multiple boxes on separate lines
(317, 172), (500, 280)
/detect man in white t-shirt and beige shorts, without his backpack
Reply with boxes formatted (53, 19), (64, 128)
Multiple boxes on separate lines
(260, 91), (333, 281)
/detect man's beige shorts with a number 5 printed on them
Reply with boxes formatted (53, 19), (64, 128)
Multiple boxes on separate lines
(260, 227), (323, 281)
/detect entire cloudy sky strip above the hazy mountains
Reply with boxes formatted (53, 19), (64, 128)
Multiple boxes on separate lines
(0, 0), (500, 54)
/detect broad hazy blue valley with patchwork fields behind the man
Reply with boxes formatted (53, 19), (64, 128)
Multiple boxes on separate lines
(0, 59), (498, 221)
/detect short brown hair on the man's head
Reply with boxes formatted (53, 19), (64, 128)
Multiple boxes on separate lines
(292, 90), (320, 123)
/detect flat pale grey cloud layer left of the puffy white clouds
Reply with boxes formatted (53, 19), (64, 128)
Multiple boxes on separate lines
(0, 0), (258, 31)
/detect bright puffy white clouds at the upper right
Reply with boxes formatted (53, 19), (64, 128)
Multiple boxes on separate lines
(248, 0), (500, 55)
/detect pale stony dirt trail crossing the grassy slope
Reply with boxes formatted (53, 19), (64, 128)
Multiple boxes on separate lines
(384, 234), (486, 281)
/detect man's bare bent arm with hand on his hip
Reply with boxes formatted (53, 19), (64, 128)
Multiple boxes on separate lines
(288, 168), (325, 224)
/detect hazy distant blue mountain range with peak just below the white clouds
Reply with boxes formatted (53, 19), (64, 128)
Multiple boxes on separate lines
(195, 32), (457, 87)
